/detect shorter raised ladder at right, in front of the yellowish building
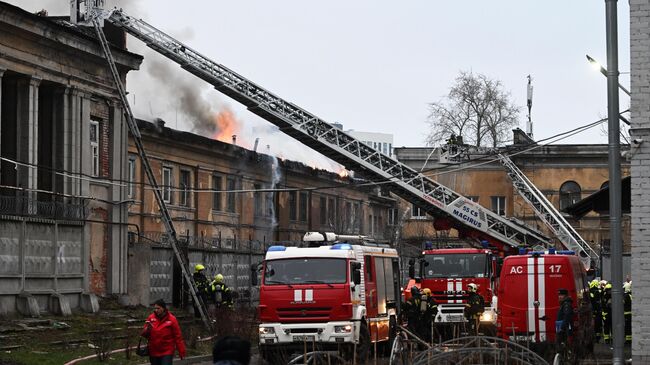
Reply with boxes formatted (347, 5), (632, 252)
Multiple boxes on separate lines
(499, 154), (598, 269)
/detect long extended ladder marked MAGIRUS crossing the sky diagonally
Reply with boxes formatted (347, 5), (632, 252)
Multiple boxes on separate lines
(83, 4), (548, 247)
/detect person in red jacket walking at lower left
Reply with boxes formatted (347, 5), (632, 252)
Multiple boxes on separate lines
(141, 299), (185, 365)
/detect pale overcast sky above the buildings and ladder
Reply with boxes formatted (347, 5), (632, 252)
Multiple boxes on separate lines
(9, 0), (629, 168)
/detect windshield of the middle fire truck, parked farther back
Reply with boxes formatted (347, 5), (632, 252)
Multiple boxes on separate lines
(423, 254), (487, 278)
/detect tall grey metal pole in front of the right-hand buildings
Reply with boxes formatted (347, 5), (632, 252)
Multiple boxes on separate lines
(605, 0), (625, 365)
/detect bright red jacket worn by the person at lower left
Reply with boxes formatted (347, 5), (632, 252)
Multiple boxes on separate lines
(141, 311), (185, 358)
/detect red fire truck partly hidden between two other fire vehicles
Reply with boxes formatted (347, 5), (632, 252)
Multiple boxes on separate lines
(404, 248), (498, 334)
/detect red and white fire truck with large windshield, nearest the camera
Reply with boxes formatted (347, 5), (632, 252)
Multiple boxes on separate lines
(258, 232), (400, 359)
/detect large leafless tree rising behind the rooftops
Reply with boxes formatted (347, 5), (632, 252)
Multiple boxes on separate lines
(426, 71), (519, 147)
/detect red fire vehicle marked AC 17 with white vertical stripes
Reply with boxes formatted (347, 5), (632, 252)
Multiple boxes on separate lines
(497, 249), (593, 356)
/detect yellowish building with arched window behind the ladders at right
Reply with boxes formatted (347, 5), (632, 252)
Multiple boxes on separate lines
(395, 131), (630, 253)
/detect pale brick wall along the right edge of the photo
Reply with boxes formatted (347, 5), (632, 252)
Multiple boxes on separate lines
(630, 0), (650, 358)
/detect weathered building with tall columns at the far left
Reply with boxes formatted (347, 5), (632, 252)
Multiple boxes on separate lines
(0, 3), (142, 315)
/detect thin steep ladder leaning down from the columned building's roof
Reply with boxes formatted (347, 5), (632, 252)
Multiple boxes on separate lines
(87, 17), (212, 330)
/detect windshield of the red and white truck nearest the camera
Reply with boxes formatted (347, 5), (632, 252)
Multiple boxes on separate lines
(264, 257), (347, 285)
